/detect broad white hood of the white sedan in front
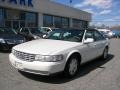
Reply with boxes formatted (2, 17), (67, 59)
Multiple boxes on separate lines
(13, 39), (81, 55)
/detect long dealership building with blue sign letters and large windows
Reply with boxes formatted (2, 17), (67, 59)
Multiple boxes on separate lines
(0, 0), (91, 29)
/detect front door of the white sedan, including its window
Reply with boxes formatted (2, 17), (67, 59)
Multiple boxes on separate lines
(83, 30), (97, 62)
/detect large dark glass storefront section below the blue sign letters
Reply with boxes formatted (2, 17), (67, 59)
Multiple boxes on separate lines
(0, 9), (38, 29)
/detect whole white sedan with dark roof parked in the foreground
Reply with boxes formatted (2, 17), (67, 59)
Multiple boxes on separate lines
(9, 29), (109, 77)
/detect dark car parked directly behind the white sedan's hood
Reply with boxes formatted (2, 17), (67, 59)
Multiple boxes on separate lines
(18, 27), (52, 41)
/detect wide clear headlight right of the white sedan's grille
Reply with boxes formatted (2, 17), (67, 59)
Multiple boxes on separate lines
(35, 55), (63, 62)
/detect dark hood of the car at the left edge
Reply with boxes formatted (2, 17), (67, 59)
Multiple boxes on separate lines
(0, 34), (24, 40)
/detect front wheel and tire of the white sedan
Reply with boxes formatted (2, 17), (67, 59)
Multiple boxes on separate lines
(64, 55), (80, 78)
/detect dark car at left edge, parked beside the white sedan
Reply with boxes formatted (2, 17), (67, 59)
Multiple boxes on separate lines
(0, 27), (24, 50)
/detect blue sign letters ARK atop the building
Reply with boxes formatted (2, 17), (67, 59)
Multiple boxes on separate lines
(1, 0), (33, 7)
